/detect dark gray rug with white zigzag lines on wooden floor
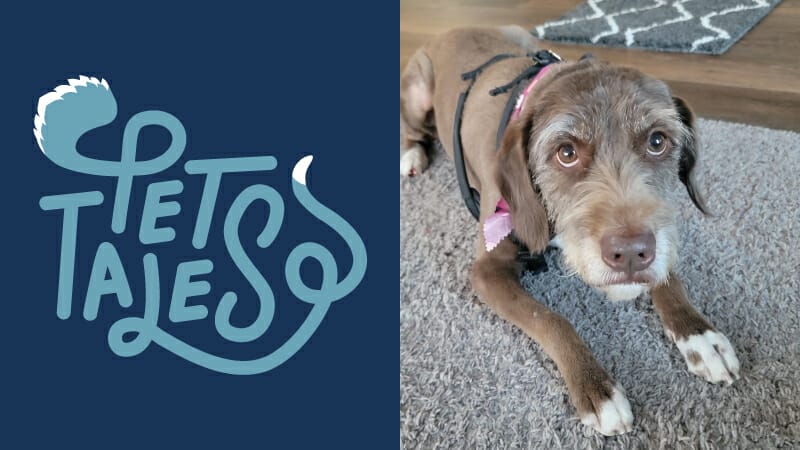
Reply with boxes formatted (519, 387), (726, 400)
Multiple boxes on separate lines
(533, 0), (780, 55)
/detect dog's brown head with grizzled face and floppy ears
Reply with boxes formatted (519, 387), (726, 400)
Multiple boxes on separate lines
(496, 60), (705, 300)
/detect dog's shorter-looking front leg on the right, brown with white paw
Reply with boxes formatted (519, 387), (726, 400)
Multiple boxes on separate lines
(652, 273), (739, 385)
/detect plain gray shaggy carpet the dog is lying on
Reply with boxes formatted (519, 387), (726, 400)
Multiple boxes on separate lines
(400, 120), (800, 449)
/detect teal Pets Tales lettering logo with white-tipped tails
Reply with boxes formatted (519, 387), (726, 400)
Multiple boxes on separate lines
(33, 76), (367, 375)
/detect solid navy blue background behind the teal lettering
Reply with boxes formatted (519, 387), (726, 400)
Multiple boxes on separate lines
(0, 2), (399, 448)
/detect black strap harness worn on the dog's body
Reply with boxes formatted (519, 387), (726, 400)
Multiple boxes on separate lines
(453, 50), (561, 273)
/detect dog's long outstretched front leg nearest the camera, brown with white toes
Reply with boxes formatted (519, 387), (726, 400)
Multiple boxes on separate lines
(470, 239), (633, 435)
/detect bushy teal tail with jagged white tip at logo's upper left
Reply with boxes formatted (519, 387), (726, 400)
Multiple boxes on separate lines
(33, 75), (117, 160)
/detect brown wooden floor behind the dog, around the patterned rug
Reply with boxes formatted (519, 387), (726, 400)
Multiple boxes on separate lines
(400, 0), (800, 131)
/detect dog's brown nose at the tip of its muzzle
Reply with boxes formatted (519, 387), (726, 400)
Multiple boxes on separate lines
(600, 232), (656, 273)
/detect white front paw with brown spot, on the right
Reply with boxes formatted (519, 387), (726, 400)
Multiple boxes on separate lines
(675, 330), (739, 386)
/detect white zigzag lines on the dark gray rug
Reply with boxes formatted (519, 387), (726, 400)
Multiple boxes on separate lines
(534, 0), (776, 51)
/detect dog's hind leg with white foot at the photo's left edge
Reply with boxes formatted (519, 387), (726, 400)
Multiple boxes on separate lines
(400, 49), (433, 177)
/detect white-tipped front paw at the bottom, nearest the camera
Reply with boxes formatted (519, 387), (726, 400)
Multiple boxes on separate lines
(578, 386), (633, 436)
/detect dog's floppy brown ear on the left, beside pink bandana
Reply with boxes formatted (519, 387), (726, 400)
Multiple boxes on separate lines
(495, 118), (550, 252)
